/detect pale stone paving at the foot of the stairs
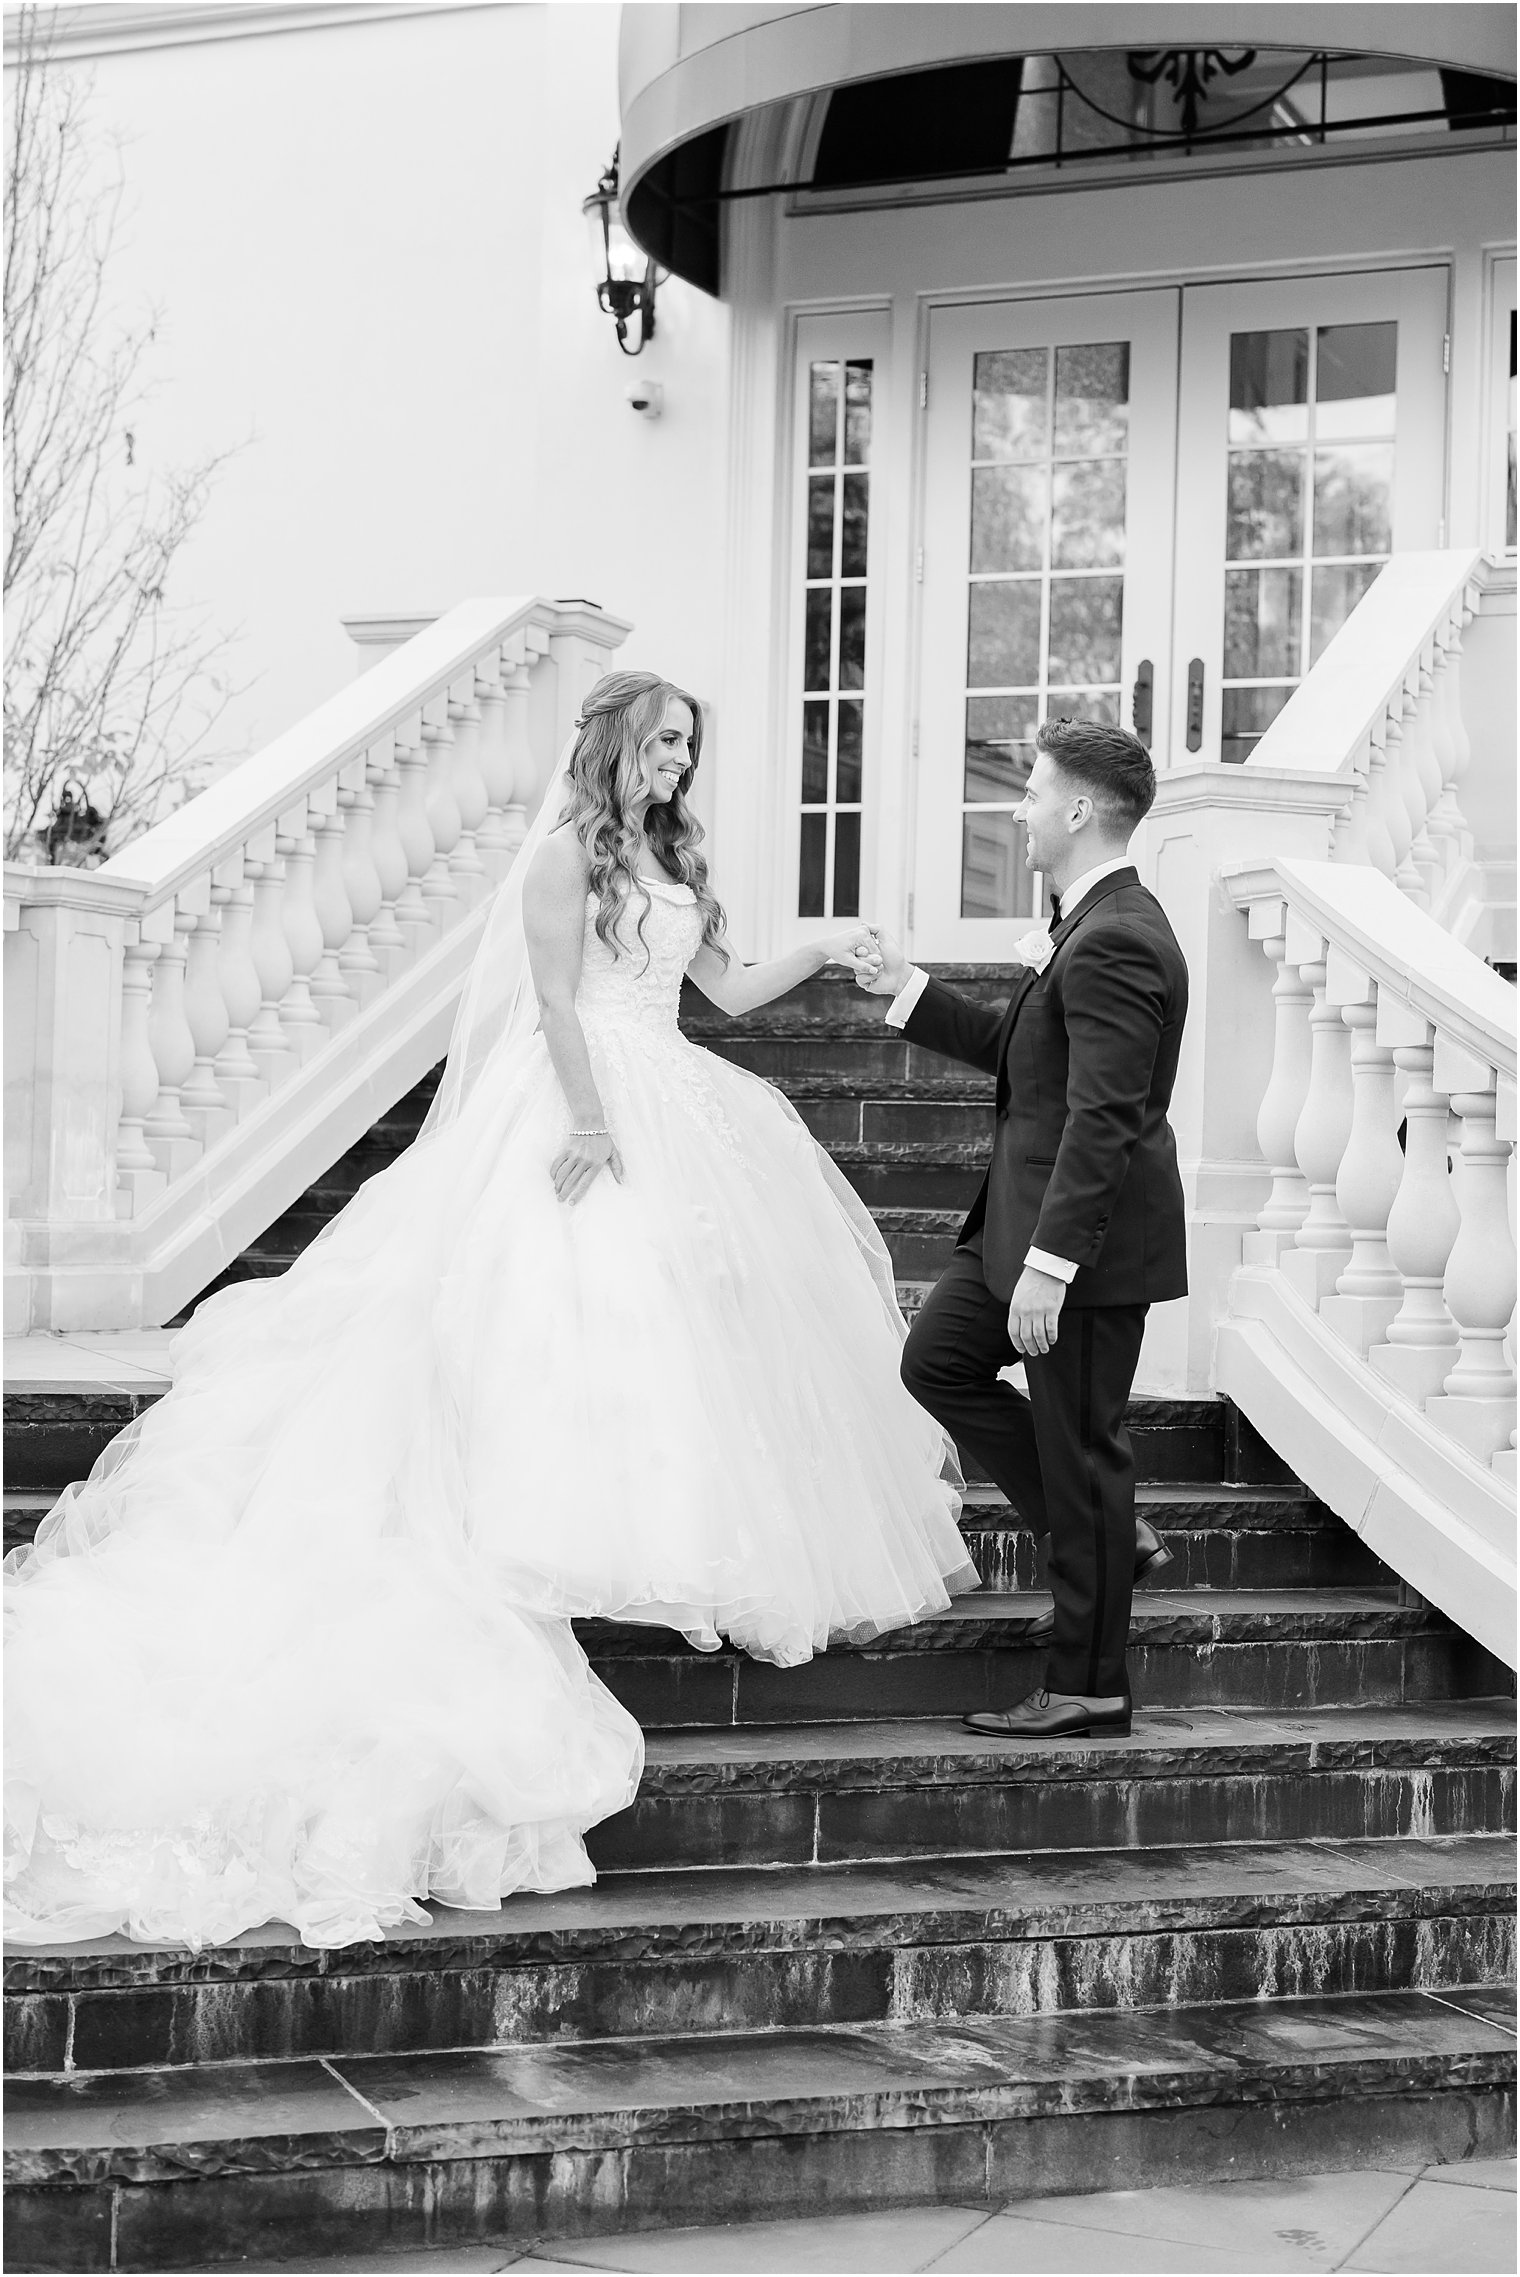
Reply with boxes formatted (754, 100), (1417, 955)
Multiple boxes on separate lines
(216, 2159), (1515, 2277)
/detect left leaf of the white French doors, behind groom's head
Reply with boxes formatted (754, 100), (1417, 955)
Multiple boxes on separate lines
(912, 291), (1176, 959)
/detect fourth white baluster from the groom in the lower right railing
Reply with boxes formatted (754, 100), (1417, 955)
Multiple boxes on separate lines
(1368, 988), (1459, 1407)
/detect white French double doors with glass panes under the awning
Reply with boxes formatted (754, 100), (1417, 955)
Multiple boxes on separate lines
(912, 269), (1447, 961)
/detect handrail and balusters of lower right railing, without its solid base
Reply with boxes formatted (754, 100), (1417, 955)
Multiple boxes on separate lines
(1229, 856), (1515, 1473)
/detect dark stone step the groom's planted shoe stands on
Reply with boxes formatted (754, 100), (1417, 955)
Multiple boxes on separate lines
(587, 1696), (1515, 1872)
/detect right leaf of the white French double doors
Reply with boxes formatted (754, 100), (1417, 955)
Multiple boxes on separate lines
(1172, 269), (1447, 763)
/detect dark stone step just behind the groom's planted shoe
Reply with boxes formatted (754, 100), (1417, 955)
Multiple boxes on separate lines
(576, 1587), (1509, 1731)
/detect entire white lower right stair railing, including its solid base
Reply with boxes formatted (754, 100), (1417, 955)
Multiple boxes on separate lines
(1215, 856), (1515, 1667)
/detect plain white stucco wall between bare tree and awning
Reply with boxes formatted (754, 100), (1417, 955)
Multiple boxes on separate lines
(20, 0), (728, 774)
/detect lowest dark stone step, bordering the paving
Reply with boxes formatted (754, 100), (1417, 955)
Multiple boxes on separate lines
(7, 1988), (1515, 2270)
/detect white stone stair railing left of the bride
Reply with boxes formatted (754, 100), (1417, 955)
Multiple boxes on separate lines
(5, 599), (628, 1332)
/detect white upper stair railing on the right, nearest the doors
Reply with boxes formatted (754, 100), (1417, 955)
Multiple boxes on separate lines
(1245, 551), (1486, 924)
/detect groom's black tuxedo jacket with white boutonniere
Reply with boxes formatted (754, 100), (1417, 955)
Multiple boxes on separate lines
(903, 868), (1188, 1305)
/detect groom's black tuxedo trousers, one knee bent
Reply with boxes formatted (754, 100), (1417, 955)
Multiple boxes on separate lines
(903, 1246), (1147, 1699)
